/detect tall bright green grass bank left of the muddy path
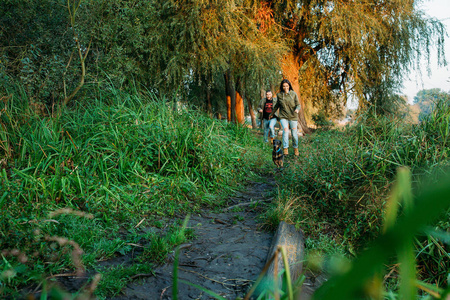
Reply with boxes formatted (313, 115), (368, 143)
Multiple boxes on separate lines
(0, 86), (269, 295)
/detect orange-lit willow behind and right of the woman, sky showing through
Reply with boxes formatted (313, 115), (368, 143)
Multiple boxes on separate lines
(265, 0), (445, 131)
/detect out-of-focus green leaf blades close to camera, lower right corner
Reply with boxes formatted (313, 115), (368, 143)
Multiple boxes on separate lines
(314, 171), (450, 299)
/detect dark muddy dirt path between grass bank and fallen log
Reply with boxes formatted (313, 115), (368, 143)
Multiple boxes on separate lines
(114, 178), (274, 300)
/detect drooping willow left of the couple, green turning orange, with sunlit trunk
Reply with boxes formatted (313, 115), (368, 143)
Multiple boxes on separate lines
(150, 0), (286, 121)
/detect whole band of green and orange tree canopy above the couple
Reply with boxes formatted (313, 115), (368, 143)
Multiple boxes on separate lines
(0, 0), (445, 124)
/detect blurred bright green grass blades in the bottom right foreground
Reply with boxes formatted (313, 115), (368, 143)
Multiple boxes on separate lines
(313, 168), (450, 299)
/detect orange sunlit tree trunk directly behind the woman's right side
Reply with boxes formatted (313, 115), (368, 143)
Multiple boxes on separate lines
(282, 53), (311, 133)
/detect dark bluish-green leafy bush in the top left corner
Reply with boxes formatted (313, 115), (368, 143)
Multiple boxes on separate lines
(0, 0), (76, 105)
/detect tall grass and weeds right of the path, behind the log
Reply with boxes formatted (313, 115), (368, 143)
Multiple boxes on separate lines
(266, 98), (450, 289)
